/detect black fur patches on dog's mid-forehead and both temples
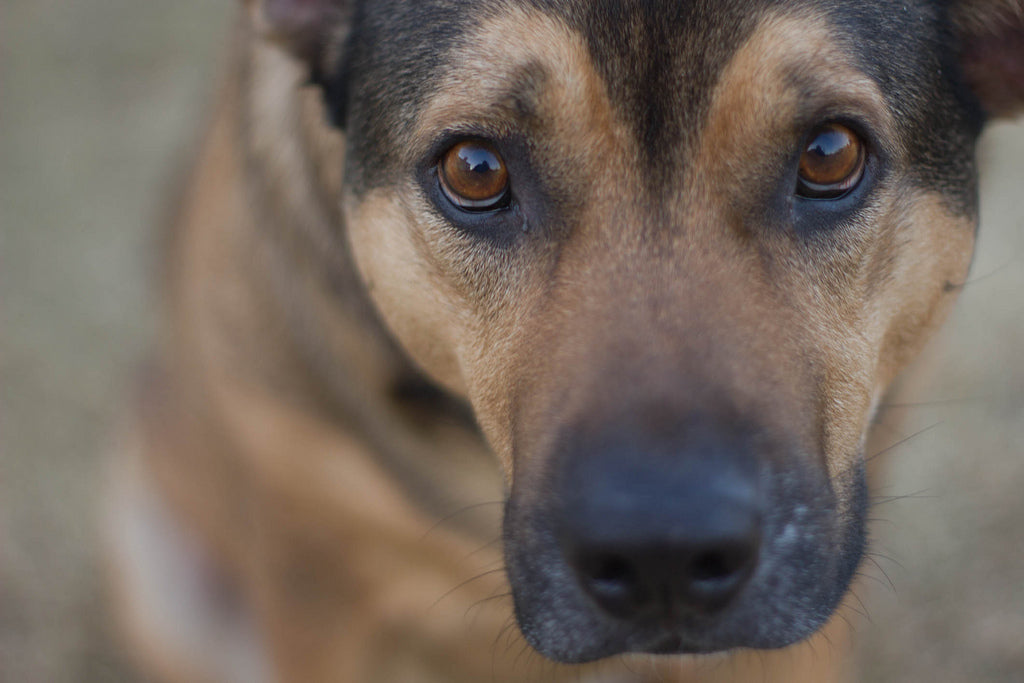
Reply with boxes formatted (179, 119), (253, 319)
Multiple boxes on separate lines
(323, 0), (983, 211)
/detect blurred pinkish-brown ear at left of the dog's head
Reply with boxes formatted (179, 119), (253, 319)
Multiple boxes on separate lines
(245, 0), (355, 64)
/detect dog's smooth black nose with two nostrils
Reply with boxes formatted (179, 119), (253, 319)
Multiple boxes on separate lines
(559, 438), (762, 620)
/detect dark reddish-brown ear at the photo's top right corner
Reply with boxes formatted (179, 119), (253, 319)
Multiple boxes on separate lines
(952, 0), (1024, 117)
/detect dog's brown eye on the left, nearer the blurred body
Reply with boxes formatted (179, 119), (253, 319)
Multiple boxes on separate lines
(437, 140), (509, 211)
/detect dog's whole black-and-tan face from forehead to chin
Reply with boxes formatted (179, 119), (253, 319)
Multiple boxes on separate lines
(256, 0), (1024, 661)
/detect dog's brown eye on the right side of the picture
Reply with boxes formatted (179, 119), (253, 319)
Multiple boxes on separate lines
(797, 123), (866, 200)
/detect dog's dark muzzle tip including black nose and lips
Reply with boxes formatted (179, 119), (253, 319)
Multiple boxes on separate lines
(505, 428), (866, 663)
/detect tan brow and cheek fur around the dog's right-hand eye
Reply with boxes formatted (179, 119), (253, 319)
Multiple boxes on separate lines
(692, 14), (974, 485)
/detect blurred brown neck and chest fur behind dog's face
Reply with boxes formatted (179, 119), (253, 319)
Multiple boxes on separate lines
(110, 29), (846, 683)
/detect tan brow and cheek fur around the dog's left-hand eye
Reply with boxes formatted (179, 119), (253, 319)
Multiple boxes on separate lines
(346, 8), (637, 476)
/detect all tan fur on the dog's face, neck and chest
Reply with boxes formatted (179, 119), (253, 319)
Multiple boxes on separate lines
(112, 9), (991, 683)
